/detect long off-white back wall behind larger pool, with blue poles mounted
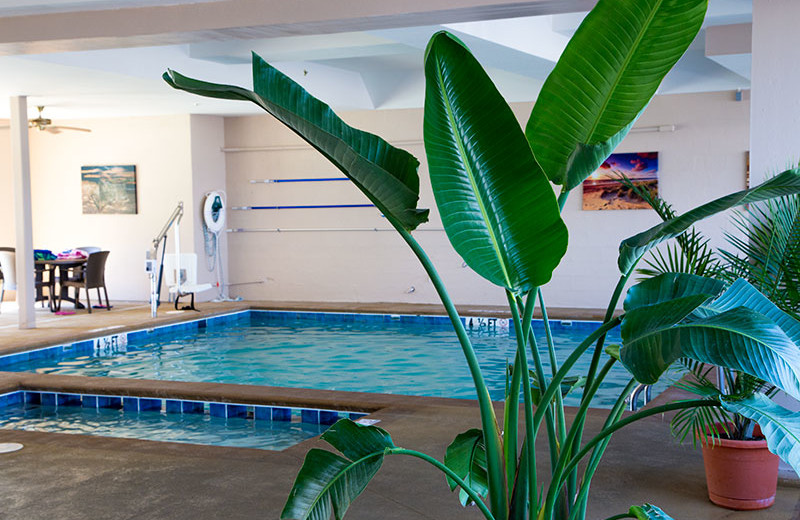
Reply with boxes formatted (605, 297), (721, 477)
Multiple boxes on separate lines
(225, 93), (749, 308)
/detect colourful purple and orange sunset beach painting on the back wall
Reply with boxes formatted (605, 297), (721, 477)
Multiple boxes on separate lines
(583, 152), (658, 210)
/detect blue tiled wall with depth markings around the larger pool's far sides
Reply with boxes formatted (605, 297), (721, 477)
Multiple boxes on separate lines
(0, 309), (600, 371)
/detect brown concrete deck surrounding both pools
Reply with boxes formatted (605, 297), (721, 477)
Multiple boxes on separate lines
(0, 302), (800, 520)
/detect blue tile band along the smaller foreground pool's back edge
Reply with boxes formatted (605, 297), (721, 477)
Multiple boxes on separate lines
(0, 390), (367, 425)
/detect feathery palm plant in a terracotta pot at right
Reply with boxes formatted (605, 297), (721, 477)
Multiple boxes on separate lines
(622, 179), (800, 510)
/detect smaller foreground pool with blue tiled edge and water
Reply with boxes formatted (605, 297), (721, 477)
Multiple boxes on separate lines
(0, 391), (364, 451)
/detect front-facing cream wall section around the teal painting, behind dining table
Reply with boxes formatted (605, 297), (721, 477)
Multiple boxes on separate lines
(30, 116), (195, 301)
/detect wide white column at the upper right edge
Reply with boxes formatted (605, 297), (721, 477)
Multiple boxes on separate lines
(750, 0), (800, 186)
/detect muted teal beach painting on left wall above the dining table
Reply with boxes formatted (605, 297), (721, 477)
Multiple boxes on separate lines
(81, 164), (136, 214)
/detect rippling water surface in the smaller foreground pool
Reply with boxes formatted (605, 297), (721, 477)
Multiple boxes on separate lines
(0, 403), (328, 450)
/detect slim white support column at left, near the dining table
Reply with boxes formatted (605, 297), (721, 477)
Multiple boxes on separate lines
(11, 96), (36, 329)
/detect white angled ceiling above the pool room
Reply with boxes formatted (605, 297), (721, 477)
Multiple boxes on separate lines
(0, 0), (752, 123)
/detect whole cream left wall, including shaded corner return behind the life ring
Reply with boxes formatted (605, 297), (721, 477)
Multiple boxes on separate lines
(0, 115), (225, 301)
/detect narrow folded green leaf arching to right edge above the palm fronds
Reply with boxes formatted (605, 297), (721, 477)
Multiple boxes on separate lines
(617, 169), (800, 273)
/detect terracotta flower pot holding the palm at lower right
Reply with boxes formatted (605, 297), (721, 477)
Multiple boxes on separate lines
(703, 424), (780, 510)
